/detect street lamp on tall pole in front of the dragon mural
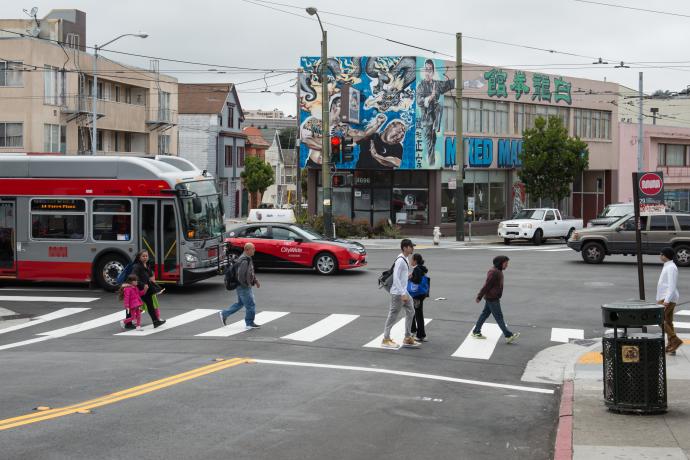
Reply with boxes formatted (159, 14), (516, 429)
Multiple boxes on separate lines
(307, 6), (335, 238)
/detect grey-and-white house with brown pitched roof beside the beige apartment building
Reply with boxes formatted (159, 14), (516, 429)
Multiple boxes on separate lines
(179, 83), (248, 218)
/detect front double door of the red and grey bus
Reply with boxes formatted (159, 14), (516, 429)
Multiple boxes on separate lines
(139, 200), (180, 283)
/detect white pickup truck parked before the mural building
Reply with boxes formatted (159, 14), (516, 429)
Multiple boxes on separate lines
(498, 208), (582, 245)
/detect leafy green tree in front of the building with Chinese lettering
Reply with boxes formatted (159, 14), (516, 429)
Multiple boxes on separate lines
(518, 117), (589, 204)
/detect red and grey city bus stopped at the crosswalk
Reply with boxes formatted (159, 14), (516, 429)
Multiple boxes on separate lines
(0, 154), (225, 290)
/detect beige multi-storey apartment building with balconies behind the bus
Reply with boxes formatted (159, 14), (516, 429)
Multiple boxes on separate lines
(0, 10), (178, 155)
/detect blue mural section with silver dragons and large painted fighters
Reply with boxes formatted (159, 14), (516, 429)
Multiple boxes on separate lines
(300, 56), (416, 169)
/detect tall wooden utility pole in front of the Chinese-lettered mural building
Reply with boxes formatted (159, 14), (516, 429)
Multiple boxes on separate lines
(455, 33), (465, 241)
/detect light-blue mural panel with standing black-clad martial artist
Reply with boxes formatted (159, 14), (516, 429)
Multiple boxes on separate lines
(415, 58), (455, 169)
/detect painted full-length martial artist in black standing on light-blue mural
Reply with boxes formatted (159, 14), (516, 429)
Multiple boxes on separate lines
(417, 59), (455, 168)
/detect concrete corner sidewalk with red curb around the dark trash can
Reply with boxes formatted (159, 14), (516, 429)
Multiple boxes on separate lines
(554, 334), (690, 460)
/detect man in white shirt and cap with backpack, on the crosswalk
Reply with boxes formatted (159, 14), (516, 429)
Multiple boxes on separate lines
(381, 238), (419, 348)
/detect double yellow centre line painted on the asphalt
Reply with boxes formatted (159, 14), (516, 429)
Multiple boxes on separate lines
(0, 358), (253, 431)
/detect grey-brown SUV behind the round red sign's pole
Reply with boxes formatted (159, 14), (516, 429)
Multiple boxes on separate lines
(568, 212), (690, 267)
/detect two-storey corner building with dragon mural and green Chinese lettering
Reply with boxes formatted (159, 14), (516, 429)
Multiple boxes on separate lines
(300, 56), (618, 231)
